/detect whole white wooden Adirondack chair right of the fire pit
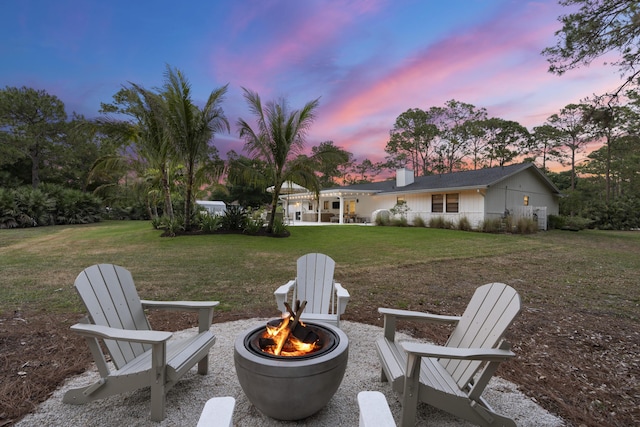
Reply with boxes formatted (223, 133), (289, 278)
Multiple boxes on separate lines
(376, 283), (520, 427)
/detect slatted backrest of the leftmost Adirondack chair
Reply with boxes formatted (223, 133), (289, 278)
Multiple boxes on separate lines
(75, 264), (151, 369)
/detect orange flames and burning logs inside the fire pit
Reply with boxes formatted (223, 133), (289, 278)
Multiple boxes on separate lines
(260, 316), (321, 357)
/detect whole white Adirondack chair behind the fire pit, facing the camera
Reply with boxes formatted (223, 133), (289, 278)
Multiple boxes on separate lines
(274, 253), (349, 327)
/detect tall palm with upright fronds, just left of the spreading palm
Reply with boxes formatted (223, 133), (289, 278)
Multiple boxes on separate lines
(162, 66), (229, 230)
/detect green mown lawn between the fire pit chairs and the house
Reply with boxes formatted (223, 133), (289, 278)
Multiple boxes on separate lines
(0, 221), (545, 313)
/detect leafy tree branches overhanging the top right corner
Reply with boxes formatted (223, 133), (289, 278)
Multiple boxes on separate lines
(542, 0), (640, 91)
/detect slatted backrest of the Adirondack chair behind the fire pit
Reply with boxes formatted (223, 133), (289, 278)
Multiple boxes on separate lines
(293, 253), (336, 314)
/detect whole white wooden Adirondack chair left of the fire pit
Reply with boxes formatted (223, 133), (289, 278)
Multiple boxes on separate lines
(63, 264), (218, 421)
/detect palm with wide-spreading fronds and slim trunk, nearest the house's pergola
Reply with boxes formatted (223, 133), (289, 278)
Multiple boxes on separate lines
(238, 88), (319, 233)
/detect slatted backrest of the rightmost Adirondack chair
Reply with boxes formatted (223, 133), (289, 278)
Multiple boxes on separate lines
(440, 283), (520, 389)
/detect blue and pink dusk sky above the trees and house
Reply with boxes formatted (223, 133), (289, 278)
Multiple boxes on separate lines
(0, 0), (620, 170)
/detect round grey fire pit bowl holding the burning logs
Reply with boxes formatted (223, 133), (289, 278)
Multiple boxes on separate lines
(234, 322), (349, 421)
